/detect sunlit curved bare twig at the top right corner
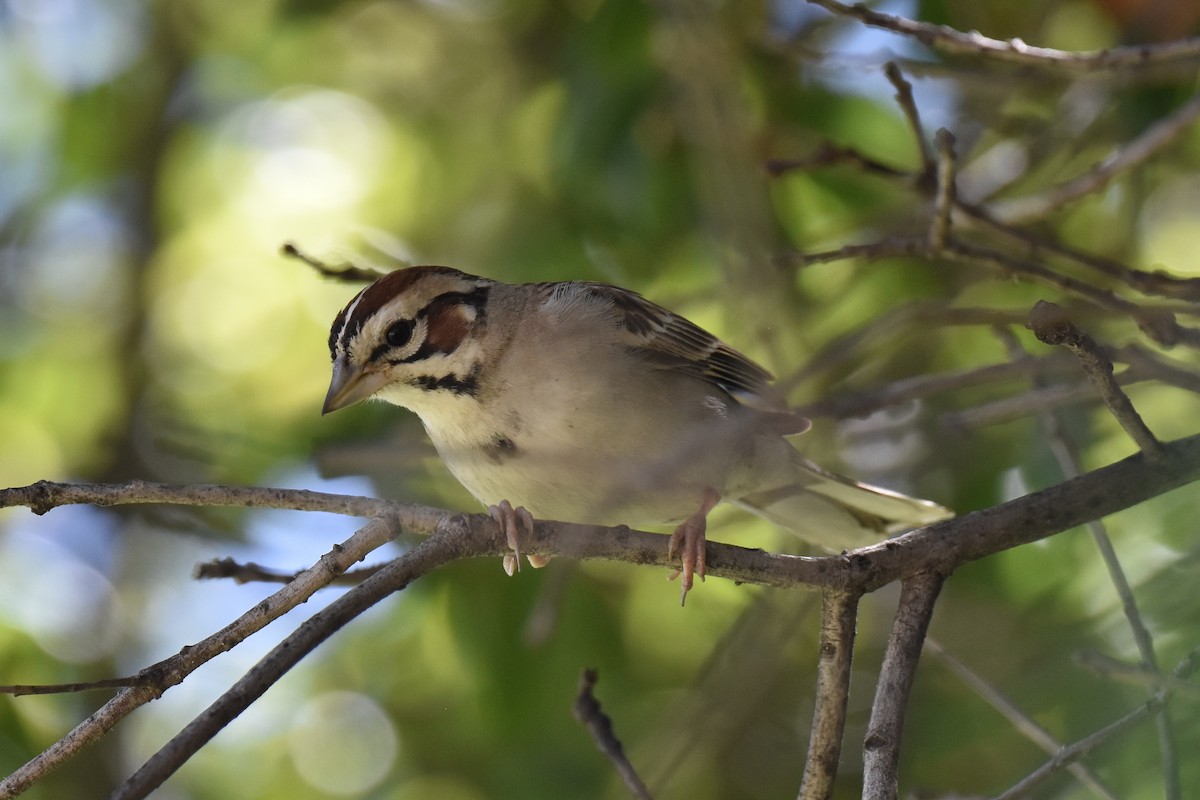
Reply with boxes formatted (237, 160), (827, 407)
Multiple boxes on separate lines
(809, 0), (1200, 73)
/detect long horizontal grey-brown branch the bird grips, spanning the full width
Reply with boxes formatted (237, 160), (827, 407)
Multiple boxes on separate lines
(7, 434), (1200, 596)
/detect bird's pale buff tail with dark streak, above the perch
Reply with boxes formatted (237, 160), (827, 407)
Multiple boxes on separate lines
(732, 458), (954, 552)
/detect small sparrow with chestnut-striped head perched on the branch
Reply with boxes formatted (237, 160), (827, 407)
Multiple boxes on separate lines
(322, 266), (953, 602)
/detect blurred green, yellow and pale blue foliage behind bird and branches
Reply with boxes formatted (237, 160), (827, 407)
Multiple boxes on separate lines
(0, 0), (1200, 800)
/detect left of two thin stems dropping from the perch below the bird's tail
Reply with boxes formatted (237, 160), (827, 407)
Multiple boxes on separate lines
(798, 591), (859, 800)
